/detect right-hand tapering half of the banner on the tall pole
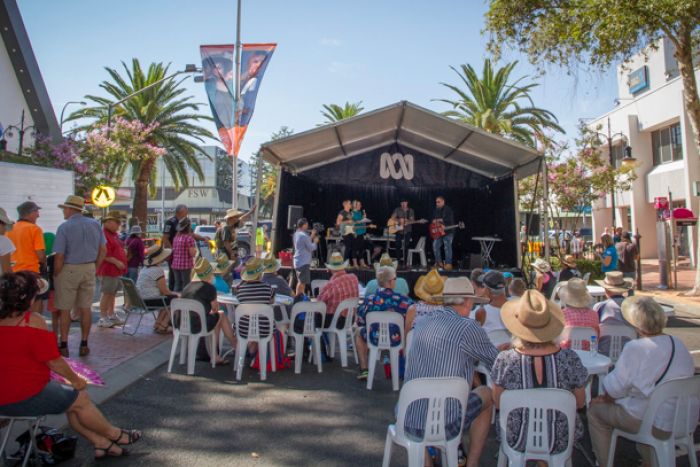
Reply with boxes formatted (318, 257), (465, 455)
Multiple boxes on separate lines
(234, 44), (277, 154)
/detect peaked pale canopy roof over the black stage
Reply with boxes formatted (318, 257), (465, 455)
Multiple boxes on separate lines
(262, 101), (541, 180)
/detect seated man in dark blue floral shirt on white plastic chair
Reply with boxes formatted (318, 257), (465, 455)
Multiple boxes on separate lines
(355, 266), (413, 380)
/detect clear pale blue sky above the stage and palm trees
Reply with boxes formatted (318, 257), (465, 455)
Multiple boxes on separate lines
(18, 0), (616, 163)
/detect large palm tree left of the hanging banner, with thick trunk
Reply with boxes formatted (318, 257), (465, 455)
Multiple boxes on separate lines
(68, 58), (214, 223)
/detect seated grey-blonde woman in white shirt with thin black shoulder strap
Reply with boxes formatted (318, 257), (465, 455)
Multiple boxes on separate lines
(587, 296), (698, 465)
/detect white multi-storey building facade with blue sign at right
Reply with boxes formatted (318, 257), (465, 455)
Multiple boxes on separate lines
(588, 39), (700, 260)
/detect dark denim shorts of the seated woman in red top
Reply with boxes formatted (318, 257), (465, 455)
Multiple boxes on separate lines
(0, 381), (79, 417)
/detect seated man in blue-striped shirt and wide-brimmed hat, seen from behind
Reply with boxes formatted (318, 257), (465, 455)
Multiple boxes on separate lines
(404, 277), (498, 466)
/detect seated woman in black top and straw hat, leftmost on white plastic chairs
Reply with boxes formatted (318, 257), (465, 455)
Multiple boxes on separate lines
(175, 257), (236, 365)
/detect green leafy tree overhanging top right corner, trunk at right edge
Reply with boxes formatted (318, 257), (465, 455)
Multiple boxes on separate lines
(486, 0), (700, 295)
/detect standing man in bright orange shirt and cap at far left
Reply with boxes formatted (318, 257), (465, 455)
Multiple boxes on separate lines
(7, 201), (48, 313)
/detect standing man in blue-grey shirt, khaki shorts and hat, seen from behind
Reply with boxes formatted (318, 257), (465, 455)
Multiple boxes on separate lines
(53, 195), (107, 357)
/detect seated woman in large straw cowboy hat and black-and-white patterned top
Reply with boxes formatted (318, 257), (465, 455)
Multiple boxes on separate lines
(491, 290), (592, 456)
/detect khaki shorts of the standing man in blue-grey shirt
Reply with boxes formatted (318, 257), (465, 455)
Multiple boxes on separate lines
(54, 263), (95, 311)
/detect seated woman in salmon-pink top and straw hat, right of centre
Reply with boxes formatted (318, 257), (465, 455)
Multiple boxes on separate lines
(559, 278), (600, 350)
